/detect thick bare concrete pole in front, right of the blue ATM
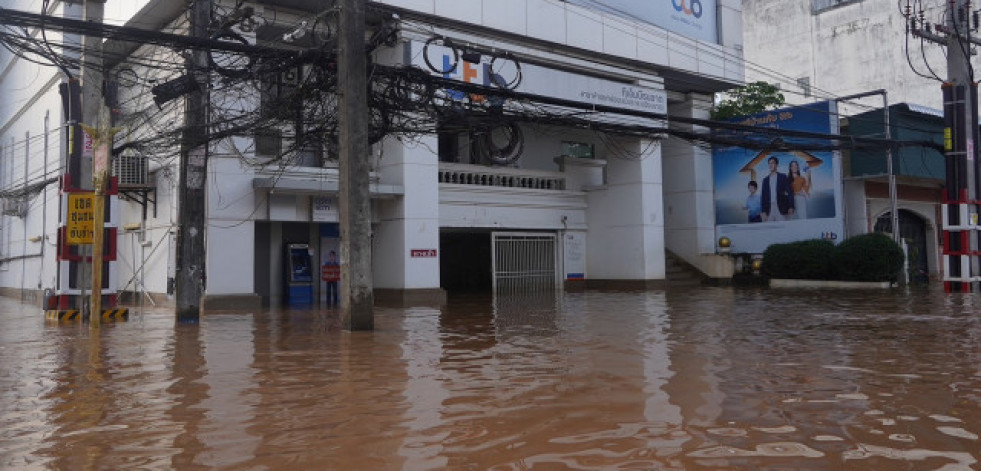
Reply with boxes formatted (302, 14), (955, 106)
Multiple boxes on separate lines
(337, 0), (374, 330)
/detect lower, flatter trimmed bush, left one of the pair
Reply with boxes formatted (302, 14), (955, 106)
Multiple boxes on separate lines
(763, 239), (835, 280)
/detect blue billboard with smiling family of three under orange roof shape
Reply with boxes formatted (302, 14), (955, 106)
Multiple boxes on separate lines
(713, 102), (844, 253)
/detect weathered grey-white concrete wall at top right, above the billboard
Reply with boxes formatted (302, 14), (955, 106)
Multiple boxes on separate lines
(742, 0), (946, 113)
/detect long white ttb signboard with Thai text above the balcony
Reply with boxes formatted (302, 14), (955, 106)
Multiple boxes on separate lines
(408, 42), (668, 118)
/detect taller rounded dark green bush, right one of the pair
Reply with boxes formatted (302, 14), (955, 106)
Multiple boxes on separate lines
(832, 233), (904, 282)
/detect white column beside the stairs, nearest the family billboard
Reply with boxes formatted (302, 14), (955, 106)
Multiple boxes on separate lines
(663, 95), (731, 277)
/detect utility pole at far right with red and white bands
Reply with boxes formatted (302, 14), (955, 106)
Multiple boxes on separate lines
(906, 0), (981, 293)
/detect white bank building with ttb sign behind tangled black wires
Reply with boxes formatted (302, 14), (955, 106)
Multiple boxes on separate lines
(0, 0), (743, 309)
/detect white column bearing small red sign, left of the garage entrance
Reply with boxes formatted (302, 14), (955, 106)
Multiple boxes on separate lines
(373, 136), (441, 306)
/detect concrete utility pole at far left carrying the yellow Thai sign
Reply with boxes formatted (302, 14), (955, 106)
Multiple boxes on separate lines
(80, 0), (105, 328)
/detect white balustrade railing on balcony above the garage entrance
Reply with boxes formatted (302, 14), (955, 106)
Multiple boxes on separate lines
(439, 163), (566, 190)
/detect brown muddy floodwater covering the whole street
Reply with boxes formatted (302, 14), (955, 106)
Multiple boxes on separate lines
(0, 288), (981, 471)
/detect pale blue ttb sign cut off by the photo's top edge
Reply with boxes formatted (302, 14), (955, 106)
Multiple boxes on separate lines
(566, 0), (719, 43)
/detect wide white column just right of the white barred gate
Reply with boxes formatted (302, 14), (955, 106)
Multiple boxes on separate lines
(586, 139), (664, 281)
